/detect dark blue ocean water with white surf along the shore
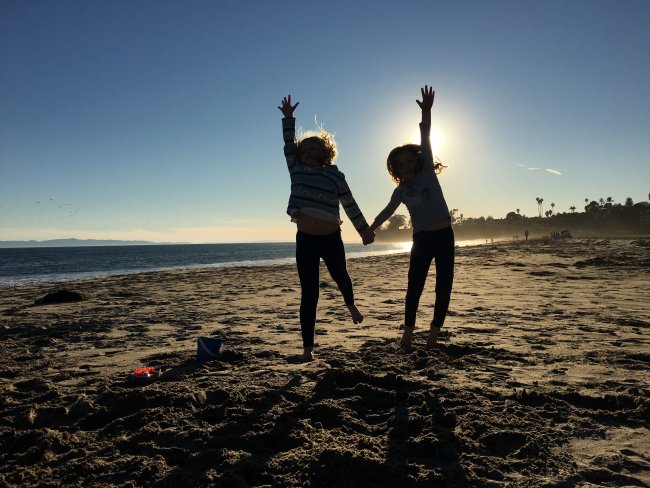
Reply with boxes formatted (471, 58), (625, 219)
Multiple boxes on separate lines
(0, 242), (411, 287)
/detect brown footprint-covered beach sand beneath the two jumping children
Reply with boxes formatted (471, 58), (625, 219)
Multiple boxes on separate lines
(0, 239), (650, 488)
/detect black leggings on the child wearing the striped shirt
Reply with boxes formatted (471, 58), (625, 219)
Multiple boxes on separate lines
(296, 230), (354, 347)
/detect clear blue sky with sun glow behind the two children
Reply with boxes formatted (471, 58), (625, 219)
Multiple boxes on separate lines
(0, 0), (650, 242)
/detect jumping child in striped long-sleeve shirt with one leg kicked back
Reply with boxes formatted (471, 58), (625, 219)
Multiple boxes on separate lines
(278, 95), (375, 361)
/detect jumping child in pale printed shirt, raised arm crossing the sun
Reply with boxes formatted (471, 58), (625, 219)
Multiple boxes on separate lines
(370, 85), (454, 351)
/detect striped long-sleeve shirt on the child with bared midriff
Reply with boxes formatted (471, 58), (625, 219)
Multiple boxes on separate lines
(282, 117), (368, 234)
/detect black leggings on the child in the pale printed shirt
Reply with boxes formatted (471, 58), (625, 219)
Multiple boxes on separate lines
(404, 226), (455, 327)
